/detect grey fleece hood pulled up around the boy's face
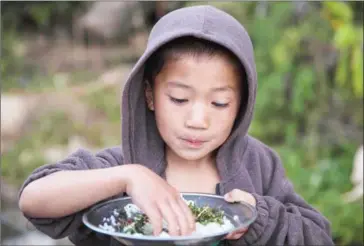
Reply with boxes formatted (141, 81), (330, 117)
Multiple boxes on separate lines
(121, 5), (257, 179)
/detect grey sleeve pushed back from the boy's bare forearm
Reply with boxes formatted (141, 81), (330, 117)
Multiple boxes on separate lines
(19, 147), (123, 239)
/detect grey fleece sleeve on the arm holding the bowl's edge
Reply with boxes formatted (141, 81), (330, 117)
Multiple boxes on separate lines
(229, 147), (334, 245)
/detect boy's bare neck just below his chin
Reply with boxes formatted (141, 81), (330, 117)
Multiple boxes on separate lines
(166, 148), (215, 171)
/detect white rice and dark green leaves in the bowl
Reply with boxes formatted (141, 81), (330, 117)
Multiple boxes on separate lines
(99, 197), (236, 238)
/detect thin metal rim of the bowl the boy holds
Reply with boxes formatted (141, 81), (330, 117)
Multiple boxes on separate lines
(82, 192), (258, 241)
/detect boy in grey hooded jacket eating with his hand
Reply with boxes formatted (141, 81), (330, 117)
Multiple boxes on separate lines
(19, 6), (333, 245)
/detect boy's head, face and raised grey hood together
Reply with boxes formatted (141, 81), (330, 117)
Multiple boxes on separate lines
(122, 6), (256, 178)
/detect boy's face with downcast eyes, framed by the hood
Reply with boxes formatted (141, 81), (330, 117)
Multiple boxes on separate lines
(146, 55), (241, 161)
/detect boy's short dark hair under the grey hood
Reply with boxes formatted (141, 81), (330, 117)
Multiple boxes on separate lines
(144, 36), (248, 122)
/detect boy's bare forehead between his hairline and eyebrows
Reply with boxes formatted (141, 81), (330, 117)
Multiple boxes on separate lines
(157, 55), (240, 89)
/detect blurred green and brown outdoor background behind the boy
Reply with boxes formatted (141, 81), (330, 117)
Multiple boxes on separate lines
(0, 1), (363, 245)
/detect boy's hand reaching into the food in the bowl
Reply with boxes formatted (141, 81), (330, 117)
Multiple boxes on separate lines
(126, 164), (195, 236)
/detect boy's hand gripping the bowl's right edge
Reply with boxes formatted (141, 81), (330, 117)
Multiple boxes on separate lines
(224, 189), (256, 240)
